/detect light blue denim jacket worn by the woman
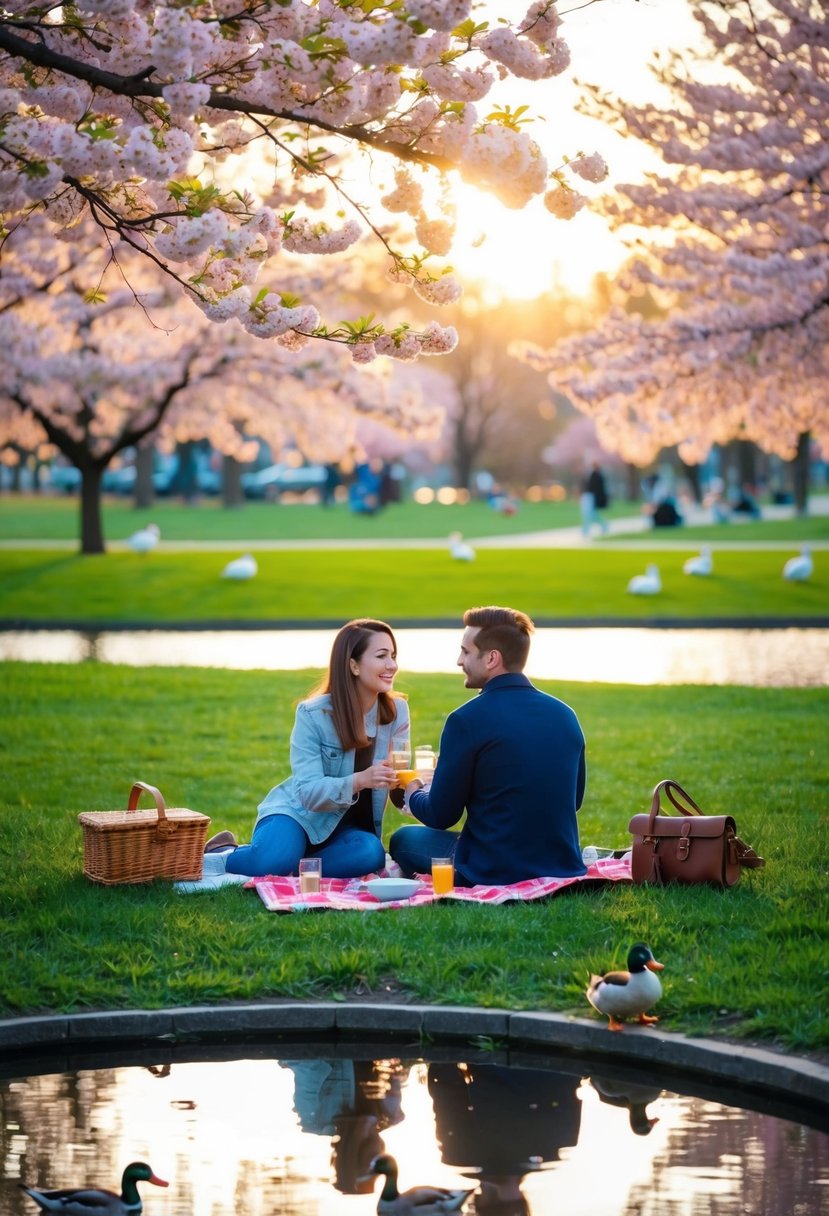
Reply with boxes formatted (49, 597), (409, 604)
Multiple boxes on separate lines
(251, 693), (408, 845)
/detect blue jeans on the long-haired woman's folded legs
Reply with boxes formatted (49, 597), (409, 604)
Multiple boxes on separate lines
(225, 815), (385, 878)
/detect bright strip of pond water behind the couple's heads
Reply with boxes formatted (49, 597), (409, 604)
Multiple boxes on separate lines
(0, 627), (829, 688)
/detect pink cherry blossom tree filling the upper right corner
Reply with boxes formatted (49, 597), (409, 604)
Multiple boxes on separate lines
(512, 0), (829, 510)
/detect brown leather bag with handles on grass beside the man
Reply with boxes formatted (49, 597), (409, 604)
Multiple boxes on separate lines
(628, 779), (766, 886)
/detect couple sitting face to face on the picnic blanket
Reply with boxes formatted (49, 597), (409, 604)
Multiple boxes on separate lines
(204, 607), (585, 886)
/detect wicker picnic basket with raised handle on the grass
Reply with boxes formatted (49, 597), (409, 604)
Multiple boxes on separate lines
(78, 781), (210, 886)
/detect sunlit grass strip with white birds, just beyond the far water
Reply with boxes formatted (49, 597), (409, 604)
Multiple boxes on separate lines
(0, 547), (829, 624)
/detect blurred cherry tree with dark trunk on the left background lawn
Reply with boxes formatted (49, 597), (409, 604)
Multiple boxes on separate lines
(0, 216), (440, 553)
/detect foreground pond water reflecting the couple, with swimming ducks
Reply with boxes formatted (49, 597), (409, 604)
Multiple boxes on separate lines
(0, 1043), (829, 1216)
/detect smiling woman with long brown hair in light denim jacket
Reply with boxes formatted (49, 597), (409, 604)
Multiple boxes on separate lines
(204, 620), (410, 878)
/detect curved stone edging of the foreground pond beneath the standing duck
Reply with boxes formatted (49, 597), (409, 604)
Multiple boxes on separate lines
(0, 1001), (829, 1113)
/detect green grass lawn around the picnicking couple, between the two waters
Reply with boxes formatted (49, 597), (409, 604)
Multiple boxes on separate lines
(0, 663), (829, 1051)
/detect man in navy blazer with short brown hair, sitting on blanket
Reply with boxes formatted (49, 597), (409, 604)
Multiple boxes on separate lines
(389, 607), (585, 886)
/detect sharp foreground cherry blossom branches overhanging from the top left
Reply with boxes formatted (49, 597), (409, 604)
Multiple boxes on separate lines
(0, 0), (607, 365)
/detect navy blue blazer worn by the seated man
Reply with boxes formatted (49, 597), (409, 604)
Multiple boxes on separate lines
(408, 674), (585, 885)
